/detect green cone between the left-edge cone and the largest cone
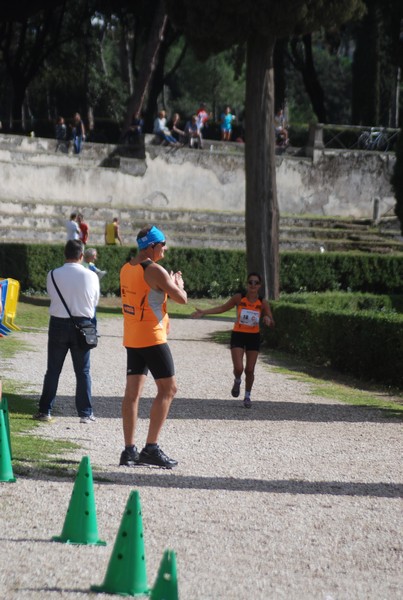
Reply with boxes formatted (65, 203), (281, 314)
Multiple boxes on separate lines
(52, 456), (106, 546)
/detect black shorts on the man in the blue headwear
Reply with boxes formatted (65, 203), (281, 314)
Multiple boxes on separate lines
(126, 344), (175, 379)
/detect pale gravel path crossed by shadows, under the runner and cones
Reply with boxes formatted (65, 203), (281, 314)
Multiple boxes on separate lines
(0, 318), (403, 600)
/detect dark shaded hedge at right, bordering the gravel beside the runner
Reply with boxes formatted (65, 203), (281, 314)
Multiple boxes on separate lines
(263, 300), (403, 388)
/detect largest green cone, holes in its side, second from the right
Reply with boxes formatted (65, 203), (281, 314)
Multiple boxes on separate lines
(91, 491), (150, 596)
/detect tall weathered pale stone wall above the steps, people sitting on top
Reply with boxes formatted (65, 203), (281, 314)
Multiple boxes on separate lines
(0, 135), (395, 218)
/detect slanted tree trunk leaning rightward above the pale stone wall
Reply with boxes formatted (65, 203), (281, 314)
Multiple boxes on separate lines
(122, 0), (168, 137)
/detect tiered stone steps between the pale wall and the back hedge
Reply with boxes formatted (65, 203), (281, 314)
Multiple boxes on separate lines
(0, 201), (403, 253)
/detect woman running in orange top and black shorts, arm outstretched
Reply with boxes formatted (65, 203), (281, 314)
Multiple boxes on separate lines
(192, 272), (274, 408)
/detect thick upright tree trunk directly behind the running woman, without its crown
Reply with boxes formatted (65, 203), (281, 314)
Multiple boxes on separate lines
(245, 34), (280, 298)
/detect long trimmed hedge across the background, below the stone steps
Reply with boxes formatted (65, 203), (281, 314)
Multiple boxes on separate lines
(0, 243), (403, 297)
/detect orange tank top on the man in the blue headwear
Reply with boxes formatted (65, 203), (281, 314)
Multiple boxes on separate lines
(120, 260), (168, 348)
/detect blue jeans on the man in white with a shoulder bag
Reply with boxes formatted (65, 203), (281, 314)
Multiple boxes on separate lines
(39, 317), (92, 417)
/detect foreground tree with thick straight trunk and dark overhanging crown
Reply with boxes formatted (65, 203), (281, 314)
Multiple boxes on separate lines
(166, 0), (364, 298)
